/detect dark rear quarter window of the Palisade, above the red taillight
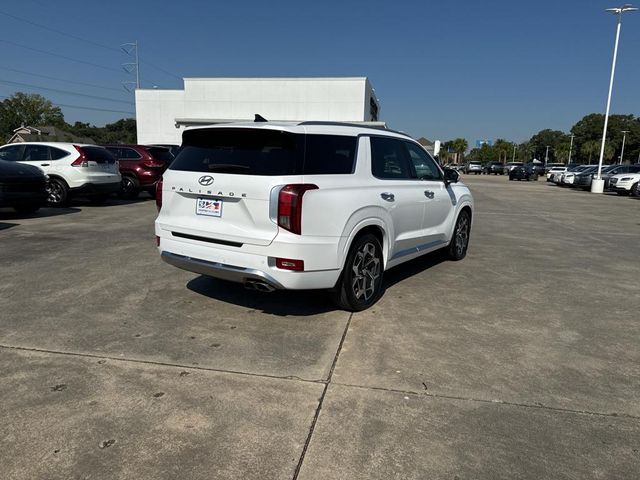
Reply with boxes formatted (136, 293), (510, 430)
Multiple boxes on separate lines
(303, 135), (358, 175)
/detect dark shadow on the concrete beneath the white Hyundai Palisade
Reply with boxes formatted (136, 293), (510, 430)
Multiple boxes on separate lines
(187, 250), (448, 317)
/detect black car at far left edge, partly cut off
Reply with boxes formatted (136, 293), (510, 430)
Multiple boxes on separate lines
(0, 160), (47, 213)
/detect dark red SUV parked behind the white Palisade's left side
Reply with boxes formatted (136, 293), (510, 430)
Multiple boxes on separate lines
(104, 145), (173, 199)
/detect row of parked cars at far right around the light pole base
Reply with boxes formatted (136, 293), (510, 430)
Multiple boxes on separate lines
(547, 164), (640, 197)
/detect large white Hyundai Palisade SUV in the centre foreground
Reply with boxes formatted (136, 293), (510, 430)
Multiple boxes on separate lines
(156, 122), (473, 311)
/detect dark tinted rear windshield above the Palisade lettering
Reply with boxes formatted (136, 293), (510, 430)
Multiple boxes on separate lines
(170, 128), (304, 175)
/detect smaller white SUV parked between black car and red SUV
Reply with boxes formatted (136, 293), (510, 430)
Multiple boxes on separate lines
(0, 142), (122, 207)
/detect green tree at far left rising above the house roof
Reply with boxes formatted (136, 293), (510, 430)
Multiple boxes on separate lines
(0, 92), (65, 138)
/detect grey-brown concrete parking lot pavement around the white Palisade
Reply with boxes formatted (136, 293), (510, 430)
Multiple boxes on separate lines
(0, 176), (640, 480)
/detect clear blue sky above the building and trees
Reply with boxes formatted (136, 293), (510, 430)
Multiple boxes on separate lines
(0, 0), (640, 144)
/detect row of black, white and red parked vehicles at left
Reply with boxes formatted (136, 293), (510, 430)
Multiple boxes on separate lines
(0, 142), (174, 213)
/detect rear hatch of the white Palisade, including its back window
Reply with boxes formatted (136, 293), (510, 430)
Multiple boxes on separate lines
(158, 127), (304, 246)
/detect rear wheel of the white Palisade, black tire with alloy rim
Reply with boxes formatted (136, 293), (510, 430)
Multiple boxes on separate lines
(332, 233), (384, 312)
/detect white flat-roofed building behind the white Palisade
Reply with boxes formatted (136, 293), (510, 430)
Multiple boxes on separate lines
(136, 77), (384, 144)
